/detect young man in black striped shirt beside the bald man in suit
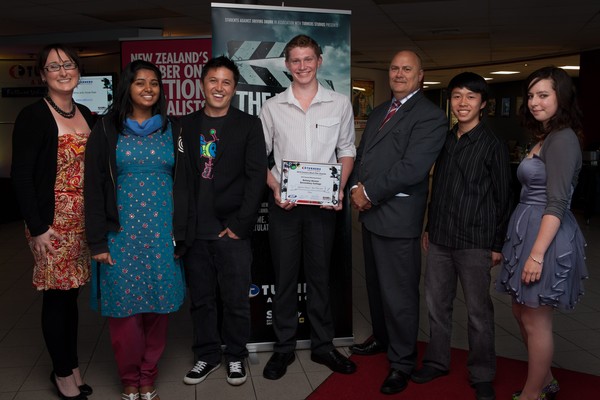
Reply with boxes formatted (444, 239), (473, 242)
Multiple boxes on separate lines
(411, 72), (511, 400)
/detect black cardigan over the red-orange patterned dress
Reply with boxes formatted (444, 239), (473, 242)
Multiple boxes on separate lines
(10, 99), (95, 236)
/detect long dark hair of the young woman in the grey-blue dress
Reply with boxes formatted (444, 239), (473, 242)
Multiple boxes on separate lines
(521, 66), (583, 142)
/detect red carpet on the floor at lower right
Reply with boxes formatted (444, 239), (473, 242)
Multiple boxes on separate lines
(308, 343), (600, 400)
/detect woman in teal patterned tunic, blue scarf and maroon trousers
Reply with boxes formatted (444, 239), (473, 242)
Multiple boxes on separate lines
(85, 61), (187, 400)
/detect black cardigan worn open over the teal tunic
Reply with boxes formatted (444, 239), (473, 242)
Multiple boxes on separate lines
(84, 115), (195, 255)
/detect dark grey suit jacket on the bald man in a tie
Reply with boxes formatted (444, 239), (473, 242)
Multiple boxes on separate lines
(350, 90), (448, 238)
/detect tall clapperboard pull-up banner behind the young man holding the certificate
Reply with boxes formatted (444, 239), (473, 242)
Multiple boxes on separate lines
(212, 3), (353, 351)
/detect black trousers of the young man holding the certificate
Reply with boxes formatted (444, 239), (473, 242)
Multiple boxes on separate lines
(269, 205), (335, 353)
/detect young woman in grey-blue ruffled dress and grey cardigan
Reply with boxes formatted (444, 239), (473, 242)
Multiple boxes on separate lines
(496, 67), (587, 400)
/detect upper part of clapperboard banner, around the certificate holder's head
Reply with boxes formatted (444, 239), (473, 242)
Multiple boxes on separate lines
(212, 3), (350, 115)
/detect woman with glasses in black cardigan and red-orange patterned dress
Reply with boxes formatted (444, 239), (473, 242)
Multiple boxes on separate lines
(11, 44), (94, 400)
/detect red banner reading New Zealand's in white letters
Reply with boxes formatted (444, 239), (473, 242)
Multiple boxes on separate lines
(121, 38), (211, 116)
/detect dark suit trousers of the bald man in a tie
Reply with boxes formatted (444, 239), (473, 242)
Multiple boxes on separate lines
(362, 225), (421, 374)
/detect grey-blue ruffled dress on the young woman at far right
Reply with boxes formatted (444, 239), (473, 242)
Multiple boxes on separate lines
(496, 155), (588, 310)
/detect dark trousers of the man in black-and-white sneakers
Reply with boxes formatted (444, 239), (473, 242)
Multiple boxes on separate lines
(185, 236), (252, 365)
